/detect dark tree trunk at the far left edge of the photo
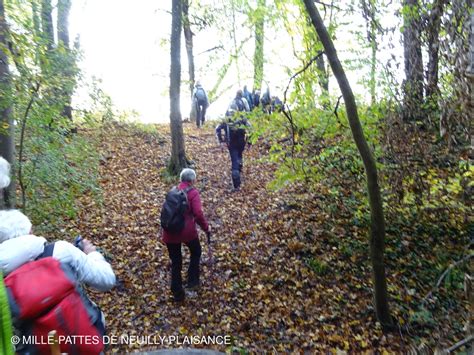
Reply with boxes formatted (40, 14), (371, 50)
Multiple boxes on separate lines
(0, 0), (15, 209)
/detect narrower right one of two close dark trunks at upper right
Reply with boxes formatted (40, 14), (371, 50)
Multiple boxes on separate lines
(426, 0), (446, 111)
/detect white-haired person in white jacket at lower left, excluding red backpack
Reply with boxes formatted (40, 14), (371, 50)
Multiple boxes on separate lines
(0, 210), (115, 291)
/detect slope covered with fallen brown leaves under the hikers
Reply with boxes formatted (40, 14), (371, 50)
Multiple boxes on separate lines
(65, 125), (468, 353)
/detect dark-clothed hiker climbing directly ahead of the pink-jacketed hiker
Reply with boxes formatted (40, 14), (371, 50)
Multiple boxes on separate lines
(216, 110), (250, 191)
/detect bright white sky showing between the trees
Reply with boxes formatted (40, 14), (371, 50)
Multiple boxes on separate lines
(70, 0), (404, 122)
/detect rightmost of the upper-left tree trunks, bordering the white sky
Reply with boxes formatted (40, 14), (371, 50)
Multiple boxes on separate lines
(58, 0), (75, 122)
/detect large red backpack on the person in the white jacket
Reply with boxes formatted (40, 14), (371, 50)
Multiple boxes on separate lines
(5, 248), (104, 354)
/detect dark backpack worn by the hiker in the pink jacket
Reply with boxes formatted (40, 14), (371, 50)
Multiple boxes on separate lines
(160, 186), (192, 234)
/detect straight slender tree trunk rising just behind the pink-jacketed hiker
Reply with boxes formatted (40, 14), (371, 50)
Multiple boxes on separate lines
(169, 0), (187, 174)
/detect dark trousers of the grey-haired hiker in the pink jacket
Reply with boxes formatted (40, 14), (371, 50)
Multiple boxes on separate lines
(166, 238), (201, 299)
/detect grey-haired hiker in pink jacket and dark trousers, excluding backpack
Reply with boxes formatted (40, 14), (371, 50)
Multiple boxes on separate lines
(162, 169), (211, 302)
